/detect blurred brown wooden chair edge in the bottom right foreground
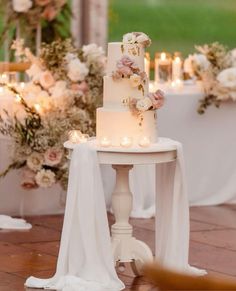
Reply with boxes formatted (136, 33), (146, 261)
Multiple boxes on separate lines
(143, 263), (236, 291)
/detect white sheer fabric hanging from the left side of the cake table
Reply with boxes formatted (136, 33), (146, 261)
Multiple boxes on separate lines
(25, 144), (125, 291)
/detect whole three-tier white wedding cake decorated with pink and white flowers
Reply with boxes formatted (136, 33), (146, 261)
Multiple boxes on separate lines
(96, 32), (163, 147)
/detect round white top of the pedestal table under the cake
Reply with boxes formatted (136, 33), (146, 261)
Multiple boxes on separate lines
(64, 138), (177, 165)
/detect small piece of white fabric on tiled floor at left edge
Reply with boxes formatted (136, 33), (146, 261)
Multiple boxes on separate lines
(0, 215), (32, 230)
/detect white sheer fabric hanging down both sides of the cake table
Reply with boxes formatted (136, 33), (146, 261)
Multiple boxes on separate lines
(26, 139), (205, 291)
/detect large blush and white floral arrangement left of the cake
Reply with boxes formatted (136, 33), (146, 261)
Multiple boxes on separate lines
(0, 40), (105, 189)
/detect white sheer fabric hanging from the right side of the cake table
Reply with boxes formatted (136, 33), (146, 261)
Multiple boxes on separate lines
(156, 140), (206, 275)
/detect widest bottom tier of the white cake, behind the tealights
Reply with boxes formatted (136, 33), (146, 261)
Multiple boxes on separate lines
(96, 107), (158, 146)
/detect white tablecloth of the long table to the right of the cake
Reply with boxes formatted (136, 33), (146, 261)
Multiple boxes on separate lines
(158, 81), (236, 205)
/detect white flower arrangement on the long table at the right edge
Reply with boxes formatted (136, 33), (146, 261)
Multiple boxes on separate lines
(184, 42), (236, 114)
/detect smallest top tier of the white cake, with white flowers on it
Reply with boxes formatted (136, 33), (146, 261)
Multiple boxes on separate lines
(107, 32), (151, 75)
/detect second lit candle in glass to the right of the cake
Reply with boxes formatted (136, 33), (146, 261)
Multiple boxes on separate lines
(155, 52), (172, 83)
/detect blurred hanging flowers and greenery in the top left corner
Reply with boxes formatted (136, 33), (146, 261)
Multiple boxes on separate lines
(0, 0), (71, 49)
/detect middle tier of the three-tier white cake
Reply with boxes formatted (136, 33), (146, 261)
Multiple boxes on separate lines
(103, 76), (148, 109)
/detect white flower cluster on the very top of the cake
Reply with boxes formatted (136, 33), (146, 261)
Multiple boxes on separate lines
(121, 32), (152, 55)
